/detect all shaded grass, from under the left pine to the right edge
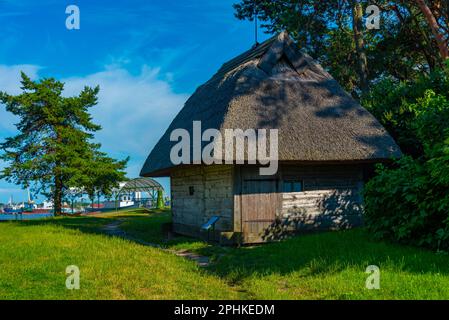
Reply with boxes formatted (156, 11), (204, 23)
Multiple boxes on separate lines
(10, 210), (449, 282)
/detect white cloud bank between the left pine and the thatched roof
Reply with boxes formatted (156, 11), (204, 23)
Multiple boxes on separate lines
(0, 65), (187, 177)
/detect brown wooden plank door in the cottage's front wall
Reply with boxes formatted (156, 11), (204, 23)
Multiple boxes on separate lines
(242, 179), (279, 242)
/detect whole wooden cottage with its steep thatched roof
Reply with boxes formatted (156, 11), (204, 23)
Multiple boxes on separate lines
(141, 32), (400, 243)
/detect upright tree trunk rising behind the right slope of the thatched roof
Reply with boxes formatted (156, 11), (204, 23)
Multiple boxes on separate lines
(352, 0), (369, 93)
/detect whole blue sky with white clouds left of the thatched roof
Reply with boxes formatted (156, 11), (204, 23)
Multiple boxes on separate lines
(0, 0), (268, 202)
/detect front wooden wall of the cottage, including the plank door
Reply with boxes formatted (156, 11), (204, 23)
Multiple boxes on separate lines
(234, 165), (363, 243)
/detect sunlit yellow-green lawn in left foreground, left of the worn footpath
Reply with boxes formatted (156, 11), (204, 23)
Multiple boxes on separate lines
(0, 210), (238, 299)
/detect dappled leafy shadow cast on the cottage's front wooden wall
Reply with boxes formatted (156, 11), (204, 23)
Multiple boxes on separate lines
(262, 191), (363, 241)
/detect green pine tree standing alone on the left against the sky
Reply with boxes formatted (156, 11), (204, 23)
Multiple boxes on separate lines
(0, 73), (127, 214)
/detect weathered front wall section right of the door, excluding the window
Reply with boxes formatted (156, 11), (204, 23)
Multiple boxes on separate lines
(281, 165), (363, 230)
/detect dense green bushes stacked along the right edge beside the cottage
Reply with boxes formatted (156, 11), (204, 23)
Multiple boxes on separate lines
(365, 73), (449, 251)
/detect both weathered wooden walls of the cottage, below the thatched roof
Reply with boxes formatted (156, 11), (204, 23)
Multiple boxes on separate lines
(171, 165), (363, 243)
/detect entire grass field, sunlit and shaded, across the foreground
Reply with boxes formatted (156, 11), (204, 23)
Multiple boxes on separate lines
(0, 210), (449, 299)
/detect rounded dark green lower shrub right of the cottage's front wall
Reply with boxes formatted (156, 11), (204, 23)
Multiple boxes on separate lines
(365, 156), (449, 251)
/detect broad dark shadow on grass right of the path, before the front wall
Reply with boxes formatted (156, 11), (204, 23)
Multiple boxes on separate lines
(206, 228), (449, 282)
